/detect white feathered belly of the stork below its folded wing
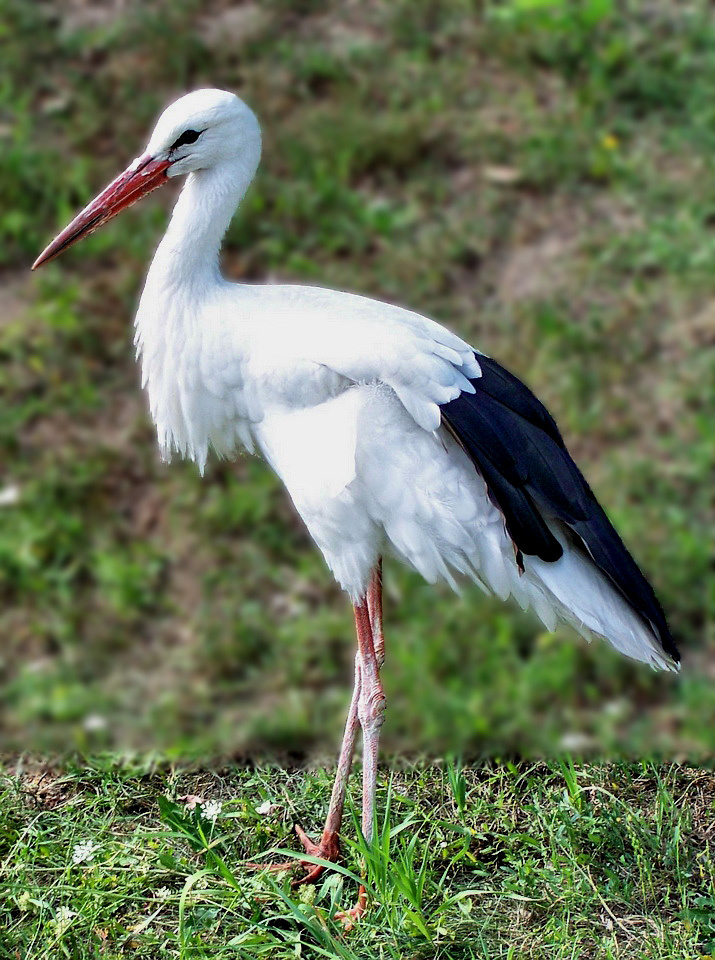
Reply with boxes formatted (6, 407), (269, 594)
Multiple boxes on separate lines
(256, 385), (510, 598)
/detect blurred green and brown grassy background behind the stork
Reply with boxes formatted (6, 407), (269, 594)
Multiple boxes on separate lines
(0, 0), (715, 759)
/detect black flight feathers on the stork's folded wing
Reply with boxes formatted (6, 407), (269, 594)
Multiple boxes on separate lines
(442, 354), (680, 662)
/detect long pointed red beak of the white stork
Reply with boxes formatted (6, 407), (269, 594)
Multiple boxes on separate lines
(32, 156), (171, 270)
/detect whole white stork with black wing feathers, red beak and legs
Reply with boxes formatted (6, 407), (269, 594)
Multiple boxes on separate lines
(33, 90), (679, 924)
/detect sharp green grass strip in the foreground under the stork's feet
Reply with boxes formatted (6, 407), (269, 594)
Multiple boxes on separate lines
(0, 757), (715, 960)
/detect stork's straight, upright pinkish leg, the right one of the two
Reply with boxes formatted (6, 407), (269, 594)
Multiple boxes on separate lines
(335, 584), (385, 930)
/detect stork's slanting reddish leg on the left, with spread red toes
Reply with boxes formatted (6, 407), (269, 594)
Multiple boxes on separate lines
(248, 559), (385, 899)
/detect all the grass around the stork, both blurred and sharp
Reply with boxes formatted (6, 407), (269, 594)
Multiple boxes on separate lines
(0, 0), (715, 960)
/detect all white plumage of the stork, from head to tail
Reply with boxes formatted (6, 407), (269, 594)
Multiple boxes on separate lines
(129, 91), (671, 667)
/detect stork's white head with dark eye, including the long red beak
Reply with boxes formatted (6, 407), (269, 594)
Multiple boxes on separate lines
(32, 90), (261, 270)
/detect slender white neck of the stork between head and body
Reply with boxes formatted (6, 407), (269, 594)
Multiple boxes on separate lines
(151, 158), (258, 284)
